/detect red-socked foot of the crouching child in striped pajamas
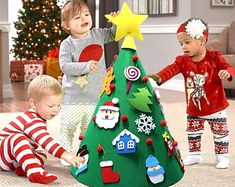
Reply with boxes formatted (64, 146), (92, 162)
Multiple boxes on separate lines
(28, 171), (57, 184)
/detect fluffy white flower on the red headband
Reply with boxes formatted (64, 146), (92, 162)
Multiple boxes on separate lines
(185, 19), (206, 39)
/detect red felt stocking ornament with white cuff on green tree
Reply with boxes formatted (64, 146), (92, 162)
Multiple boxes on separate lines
(100, 160), (120, 183)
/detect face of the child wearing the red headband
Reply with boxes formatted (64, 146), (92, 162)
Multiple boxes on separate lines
(177, 32), (205, 59)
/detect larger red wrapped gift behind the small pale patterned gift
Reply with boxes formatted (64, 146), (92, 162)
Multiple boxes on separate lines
(10, 60), (46, 81)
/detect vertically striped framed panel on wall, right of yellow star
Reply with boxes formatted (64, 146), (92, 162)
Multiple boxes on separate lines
(132, 0), (177, 16)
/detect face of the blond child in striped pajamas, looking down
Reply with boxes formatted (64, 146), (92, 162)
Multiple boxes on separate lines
(32, 95), (62, 120)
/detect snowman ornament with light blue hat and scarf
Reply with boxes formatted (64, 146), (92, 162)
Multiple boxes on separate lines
(145, 155), (165, 184)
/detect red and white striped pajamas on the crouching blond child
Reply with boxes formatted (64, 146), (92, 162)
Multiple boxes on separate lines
(0, 110), (65, 176)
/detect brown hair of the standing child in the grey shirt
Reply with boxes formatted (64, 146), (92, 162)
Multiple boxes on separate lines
(61, 0), (88, 34)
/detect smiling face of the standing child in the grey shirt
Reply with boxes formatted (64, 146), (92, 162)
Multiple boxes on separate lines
(67, 6), (92, 38)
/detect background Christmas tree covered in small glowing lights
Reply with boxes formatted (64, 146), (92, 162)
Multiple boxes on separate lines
(12, 0), (66, 60)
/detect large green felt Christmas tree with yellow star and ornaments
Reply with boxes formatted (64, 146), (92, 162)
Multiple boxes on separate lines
(71, 3), (184, 187)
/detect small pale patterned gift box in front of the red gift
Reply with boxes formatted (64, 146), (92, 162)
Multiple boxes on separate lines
(24, 64), (43, 82)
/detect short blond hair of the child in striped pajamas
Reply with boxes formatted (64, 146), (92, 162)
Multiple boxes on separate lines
(28, 75), (63, 101)
